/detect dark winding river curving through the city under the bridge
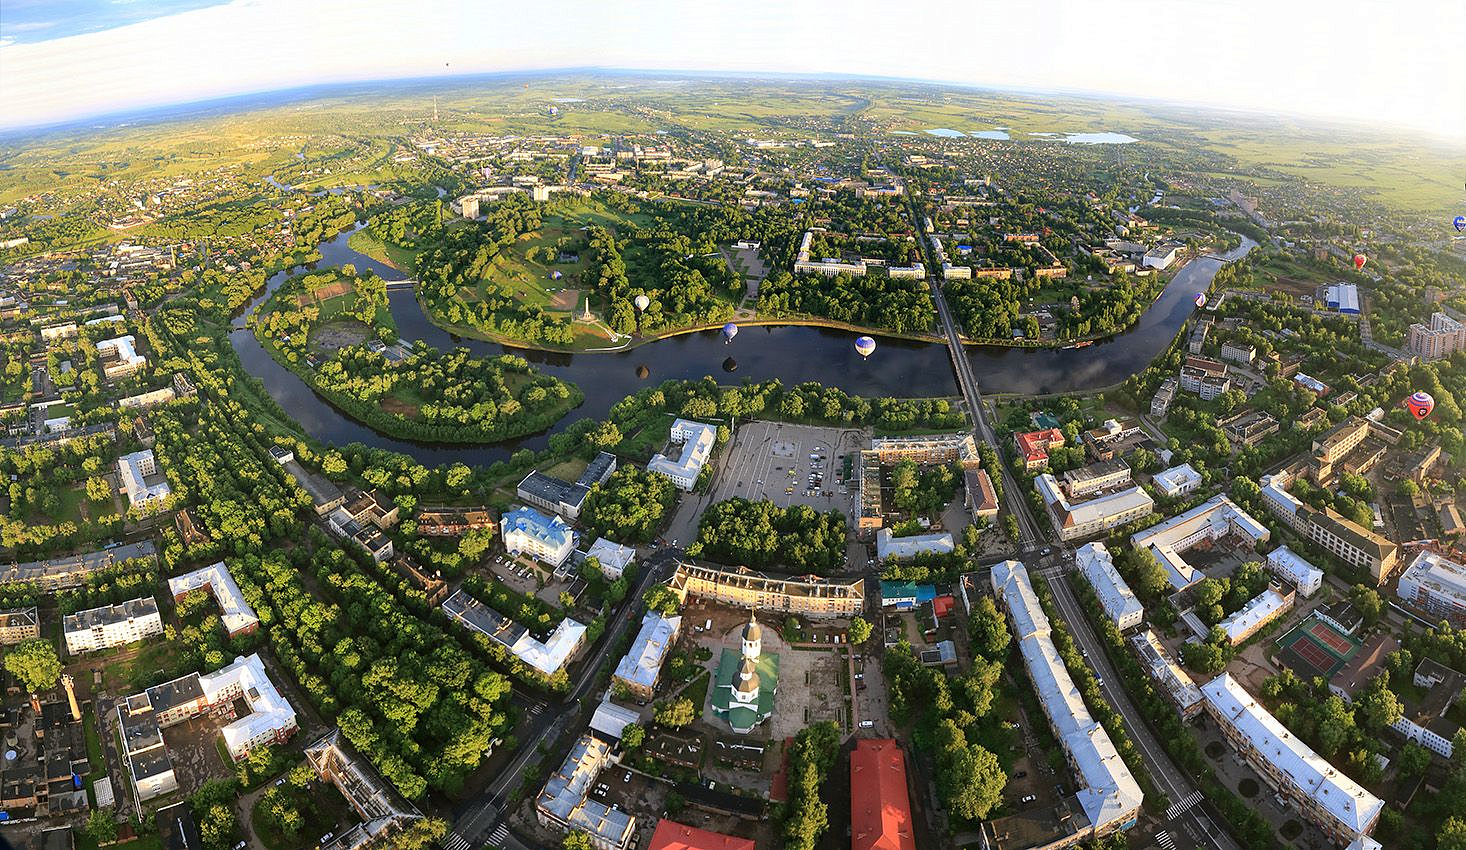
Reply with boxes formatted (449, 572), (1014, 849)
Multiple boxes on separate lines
(230, 225), (1255, 466)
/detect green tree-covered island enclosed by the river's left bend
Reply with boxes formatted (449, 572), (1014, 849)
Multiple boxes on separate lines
(254, 265), (583, 443)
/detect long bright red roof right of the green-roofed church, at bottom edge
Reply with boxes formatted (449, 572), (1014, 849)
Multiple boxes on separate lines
(850, 739), (916, 850)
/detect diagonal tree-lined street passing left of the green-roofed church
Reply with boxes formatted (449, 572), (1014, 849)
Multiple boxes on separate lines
(441, 548), (683, 850)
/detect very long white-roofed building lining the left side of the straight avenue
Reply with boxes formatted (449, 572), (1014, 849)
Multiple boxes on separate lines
(992, 561), (1145, 838)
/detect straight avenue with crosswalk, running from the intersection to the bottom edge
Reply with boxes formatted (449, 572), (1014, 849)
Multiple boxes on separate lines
(1045, 569), (1237, 850)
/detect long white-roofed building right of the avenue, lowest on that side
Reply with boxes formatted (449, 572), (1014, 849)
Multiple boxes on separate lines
(1201, 673), (1384, 850)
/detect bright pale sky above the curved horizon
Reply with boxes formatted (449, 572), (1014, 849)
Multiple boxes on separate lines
(0, 0), (1466, 142)
